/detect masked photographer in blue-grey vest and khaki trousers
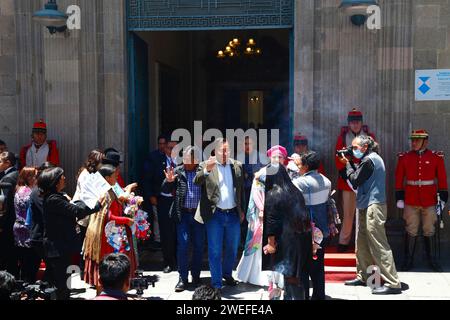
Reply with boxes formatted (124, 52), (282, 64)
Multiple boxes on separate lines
(341, 137), (401, 294)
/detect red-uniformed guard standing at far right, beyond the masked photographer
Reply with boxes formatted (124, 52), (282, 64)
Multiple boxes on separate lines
(395, 130), (448, 271)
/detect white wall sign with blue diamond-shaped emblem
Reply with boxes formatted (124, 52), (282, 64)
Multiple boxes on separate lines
(415, 69), (450, 101)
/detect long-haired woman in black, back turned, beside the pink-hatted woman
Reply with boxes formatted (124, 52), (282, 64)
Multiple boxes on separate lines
(263, 166), (312, 300)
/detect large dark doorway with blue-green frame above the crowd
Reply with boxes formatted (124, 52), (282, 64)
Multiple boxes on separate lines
(127, 0), (294, 178)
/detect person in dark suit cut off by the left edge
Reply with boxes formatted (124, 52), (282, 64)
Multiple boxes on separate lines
(0, 152), (19, 276)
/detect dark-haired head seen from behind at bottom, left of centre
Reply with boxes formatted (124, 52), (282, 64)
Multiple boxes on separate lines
(94, 253), (130, 300)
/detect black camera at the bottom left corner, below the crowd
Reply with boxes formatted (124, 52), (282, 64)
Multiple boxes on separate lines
(11, 280), (57, 300)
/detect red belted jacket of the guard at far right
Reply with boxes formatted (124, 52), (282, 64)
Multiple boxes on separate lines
(395, 150), (448, 208)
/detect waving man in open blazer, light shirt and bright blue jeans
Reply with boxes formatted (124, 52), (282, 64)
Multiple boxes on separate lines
(194, 138), (244, 289)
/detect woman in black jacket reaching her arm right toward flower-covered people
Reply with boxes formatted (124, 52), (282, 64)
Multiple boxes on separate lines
(38, 168), (101, 300)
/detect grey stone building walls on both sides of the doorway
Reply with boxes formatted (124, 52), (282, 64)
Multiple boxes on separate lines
(0, 0), (450, 250)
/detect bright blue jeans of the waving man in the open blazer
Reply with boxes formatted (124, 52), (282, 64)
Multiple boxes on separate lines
(206, 209), (241, 289)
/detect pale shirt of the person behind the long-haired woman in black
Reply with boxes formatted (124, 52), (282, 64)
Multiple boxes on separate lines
(292, 170), (331, 206)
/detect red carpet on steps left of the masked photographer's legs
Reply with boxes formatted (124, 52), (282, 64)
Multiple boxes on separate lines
(325, 247), (356, 283)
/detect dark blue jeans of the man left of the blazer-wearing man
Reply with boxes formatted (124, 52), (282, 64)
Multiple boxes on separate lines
(177, 212), (205, 280)
